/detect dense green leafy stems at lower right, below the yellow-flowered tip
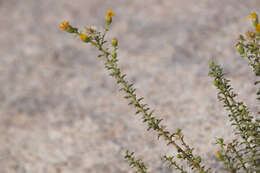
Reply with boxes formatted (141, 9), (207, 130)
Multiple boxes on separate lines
(209, 62), (260, 172)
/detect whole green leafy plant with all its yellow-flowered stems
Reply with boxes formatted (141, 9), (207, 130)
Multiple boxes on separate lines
(60, 10), (260, 173)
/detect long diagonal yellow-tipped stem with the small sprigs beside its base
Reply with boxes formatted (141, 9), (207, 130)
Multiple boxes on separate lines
(60, 10), (210, 173)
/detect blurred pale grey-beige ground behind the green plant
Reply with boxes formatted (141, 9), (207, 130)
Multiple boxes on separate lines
(0, 0), (260, 173)
